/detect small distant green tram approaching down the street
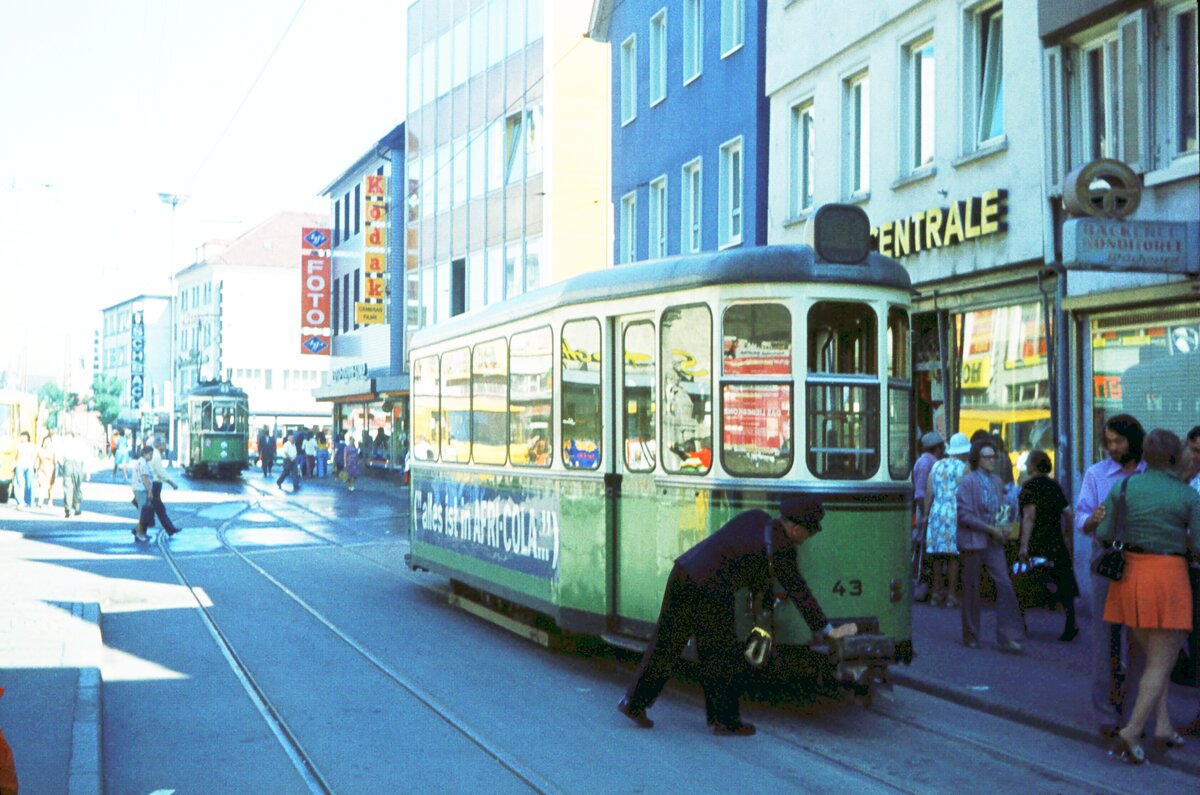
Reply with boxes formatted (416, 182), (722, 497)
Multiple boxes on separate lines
(176, 381), (250, 478)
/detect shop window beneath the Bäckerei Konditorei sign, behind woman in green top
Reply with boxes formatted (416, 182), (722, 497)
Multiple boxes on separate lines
(1085, 306), (1200, 464)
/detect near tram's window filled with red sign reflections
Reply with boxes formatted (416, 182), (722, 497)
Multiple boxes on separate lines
(721, 304), (793, 478)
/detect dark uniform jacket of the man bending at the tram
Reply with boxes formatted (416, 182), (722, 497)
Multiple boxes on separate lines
(676, 510), (827, 633)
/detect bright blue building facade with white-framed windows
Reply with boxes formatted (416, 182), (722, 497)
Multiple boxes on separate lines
(589, 0), (770, 264)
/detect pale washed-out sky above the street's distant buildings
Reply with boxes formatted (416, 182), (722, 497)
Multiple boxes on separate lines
(0, 0), (408, 386)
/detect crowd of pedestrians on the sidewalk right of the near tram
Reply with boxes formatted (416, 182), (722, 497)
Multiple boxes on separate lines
(913, 414), (1200, 764)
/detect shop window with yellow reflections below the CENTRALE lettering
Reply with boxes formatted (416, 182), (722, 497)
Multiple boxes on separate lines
(955, 301), (1054, 479)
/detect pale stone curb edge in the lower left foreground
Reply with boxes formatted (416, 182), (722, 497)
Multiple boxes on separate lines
(67, 602), (104, 795)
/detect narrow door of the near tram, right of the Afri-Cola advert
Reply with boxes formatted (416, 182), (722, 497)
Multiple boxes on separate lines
(610, 313), (662, 633)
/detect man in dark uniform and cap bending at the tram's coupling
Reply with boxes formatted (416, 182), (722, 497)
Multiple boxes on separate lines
(617, 497), (858, 736)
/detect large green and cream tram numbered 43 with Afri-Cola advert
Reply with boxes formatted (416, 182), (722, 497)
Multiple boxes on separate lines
(409, 205), (912, 685)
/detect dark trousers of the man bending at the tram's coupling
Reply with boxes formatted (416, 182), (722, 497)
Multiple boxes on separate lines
(628, 563), (743, 727)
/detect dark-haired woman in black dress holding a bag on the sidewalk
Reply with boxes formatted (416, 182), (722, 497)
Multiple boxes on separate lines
(1018, 450), (1079, 642)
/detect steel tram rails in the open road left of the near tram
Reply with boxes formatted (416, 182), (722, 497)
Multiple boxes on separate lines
(158, 502), (560, 795)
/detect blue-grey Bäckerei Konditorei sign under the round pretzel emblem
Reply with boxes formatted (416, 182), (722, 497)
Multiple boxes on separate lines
(1062, 219), (1200, 274)
